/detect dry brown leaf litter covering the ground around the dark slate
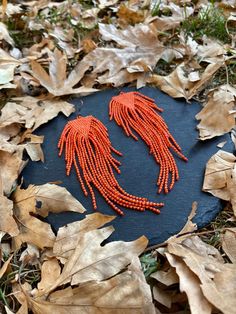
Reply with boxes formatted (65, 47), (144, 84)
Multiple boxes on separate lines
(0, 0), (236, 314)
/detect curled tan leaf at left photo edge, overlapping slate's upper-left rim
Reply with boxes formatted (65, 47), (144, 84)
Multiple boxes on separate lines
(0, 96), (75, 131)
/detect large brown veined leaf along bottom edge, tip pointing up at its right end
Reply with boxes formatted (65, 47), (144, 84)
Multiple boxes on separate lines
(27, 257), (155, 314)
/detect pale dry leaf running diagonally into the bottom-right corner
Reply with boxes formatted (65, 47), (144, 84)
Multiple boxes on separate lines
(168, 237), (236, 314)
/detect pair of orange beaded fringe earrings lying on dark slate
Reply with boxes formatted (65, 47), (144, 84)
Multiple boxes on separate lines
(58, 92), (187, 215)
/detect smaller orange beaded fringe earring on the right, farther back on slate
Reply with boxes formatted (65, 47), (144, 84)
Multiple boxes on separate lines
(109, 92), (187, 193)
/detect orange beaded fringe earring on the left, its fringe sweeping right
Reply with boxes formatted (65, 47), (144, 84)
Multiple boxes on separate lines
(58, 116), (164, 215)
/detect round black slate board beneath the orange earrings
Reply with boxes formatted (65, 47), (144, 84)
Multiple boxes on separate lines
(23, 87), (233, 245)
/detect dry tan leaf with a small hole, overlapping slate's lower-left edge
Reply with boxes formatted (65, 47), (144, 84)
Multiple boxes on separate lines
(13, 184), (84, 249)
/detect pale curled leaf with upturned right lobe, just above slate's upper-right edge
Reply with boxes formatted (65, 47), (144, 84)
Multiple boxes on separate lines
(149, 62), (223, 100)
